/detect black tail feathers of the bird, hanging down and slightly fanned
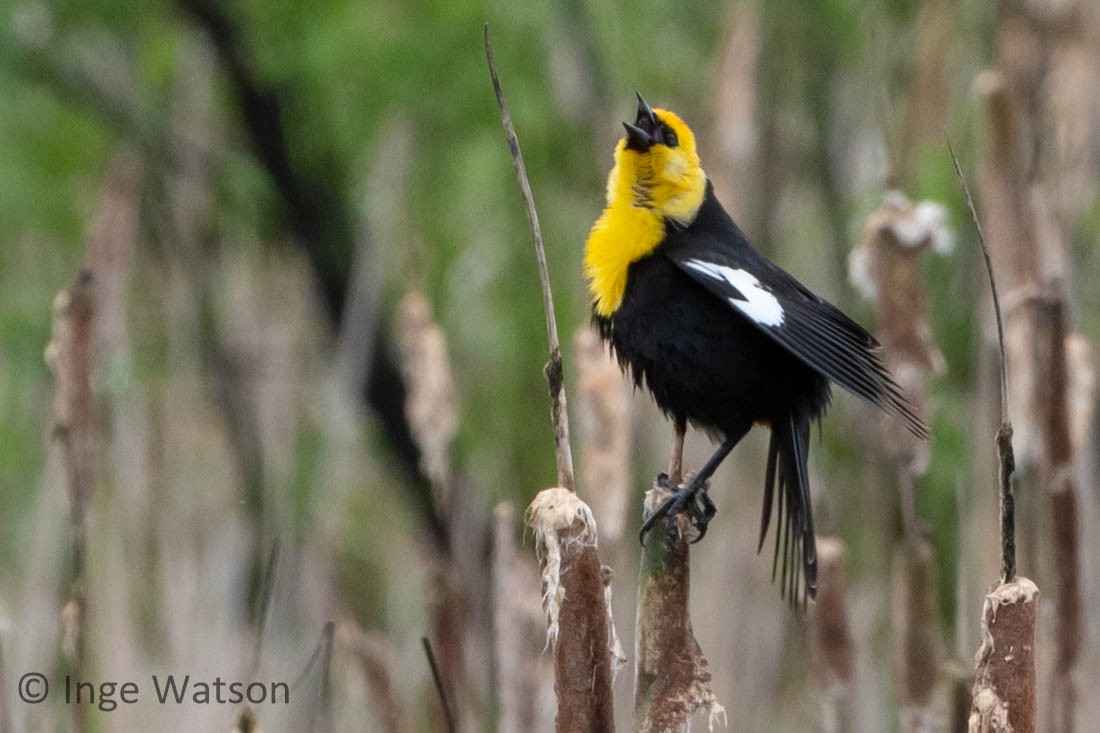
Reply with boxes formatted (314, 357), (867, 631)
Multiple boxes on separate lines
(758, 417), (817, 604)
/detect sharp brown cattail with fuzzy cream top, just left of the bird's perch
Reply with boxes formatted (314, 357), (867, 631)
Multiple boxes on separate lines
(526, 488), (623, 733)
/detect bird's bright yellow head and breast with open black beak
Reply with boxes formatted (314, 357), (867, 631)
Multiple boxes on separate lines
(584, 95), (706, 317)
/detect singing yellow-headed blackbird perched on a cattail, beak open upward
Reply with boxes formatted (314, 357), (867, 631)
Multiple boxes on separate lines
(584, 95), (928, 597)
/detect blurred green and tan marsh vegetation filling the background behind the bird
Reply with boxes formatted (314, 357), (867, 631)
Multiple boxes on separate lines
(0, 0), (1100, 731)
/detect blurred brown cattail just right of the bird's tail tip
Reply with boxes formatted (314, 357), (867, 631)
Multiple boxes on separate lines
(813, 537), (856, 733)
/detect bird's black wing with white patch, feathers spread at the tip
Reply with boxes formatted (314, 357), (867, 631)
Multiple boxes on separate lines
(662, 184), (930, 438)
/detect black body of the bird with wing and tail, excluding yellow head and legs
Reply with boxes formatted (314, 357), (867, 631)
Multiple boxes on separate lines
(595, 182), (927, 598)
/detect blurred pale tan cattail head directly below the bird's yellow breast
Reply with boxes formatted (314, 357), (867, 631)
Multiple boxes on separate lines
(573, 327), (630, 554)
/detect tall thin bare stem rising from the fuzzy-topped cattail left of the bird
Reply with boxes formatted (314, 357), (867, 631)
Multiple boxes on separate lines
(484, 23), (573, 491)
